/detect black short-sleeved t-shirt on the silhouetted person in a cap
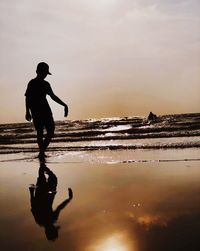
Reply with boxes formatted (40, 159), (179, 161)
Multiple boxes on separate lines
(25, 78), (53, 117)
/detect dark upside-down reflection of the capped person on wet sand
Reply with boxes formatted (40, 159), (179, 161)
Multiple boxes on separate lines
(29, 164), (73, 240)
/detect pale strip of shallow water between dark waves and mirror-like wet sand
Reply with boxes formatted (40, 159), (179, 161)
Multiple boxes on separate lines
(0, 148), (200, 164)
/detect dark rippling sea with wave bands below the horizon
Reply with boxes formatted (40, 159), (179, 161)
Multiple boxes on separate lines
(0, 113), (200, 161)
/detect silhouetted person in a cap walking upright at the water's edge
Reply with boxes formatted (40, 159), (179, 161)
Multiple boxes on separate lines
(25, 62), (68, 158)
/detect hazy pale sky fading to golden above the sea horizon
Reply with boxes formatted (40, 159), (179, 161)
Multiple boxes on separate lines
(0, 0), (200, 123)
